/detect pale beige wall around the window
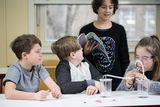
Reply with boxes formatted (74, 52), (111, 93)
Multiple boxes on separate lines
(0, 0), (160, 67)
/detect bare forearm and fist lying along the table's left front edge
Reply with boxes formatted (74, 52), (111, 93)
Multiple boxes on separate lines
(5, 82), (49, 101)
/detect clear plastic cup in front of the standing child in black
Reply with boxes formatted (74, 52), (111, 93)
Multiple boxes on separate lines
(100, 78), (112, 98)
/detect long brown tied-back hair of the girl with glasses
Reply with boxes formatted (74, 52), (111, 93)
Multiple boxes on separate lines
(135, 35), (160, 81)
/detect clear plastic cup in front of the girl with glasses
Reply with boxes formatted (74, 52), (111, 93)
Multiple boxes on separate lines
(137, 79), (149, 98)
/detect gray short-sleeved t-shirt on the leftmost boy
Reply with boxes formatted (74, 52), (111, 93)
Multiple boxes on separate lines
(3, 61), (49, 92)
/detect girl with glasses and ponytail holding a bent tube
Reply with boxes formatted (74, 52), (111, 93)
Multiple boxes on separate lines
(117, 35), (160, 93)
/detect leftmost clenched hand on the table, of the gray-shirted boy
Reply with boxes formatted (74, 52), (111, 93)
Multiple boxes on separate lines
(34, 90), (49, 101)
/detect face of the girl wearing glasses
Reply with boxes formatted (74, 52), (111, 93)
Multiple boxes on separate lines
(136, 46), (155, 72)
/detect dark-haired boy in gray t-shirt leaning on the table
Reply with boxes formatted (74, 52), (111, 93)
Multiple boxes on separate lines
(3, 34), (61, 101)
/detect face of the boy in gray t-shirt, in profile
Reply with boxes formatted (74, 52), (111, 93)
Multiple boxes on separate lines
(27, 44), (42, 65)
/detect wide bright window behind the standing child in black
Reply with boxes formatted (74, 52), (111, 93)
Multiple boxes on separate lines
(30, 0), (160, 53)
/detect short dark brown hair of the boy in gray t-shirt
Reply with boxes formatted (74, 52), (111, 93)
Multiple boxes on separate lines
(10, 34), (42, 60)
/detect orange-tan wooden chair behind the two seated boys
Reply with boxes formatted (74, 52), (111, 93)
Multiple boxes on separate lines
(39, 60), (59, 90)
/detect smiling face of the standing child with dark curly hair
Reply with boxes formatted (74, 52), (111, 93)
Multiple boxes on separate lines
(97, 0), (114, 21)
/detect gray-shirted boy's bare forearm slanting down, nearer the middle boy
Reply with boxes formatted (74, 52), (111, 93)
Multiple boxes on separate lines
(44, 76), (62, 98)
